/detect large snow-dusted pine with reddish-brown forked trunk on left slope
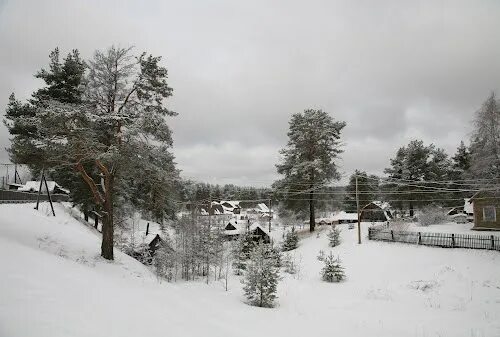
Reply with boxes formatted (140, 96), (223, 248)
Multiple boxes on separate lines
(3, 47), (178, 259)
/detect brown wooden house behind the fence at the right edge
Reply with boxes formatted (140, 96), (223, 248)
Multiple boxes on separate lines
(469, 190), (500, 230)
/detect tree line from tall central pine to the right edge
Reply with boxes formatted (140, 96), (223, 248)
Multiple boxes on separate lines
(273, 93), (500, 226)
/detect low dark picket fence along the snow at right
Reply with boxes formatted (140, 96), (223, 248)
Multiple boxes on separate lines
(368, 225), (500, 251)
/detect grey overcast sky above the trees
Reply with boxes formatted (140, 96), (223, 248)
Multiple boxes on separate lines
(0, 0), (500, 185)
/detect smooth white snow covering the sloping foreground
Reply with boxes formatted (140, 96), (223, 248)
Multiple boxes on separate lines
(0, 204), (500, 337)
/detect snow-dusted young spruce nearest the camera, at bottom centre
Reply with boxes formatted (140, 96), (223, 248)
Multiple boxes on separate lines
(242, 244), (279, 307)
